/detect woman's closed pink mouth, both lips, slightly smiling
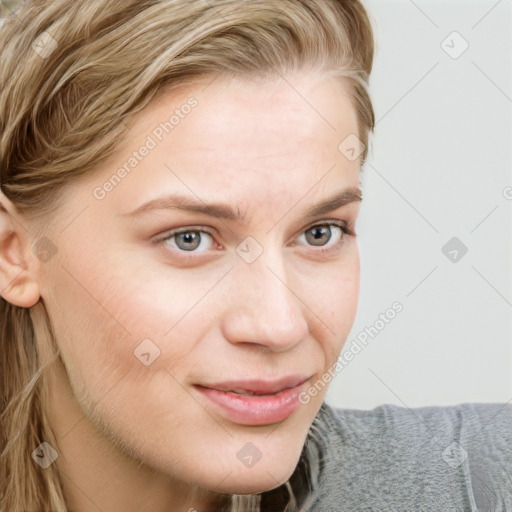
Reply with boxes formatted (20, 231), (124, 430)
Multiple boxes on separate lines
(194, 375), (311, 426)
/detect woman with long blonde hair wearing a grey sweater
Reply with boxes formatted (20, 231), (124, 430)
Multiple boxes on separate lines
(0, 0), (512, 512)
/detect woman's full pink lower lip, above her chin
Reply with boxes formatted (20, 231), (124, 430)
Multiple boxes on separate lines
(194, 383), (304, 425)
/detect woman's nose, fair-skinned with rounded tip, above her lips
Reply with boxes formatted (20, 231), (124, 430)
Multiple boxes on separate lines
(222, 244), (309, 352)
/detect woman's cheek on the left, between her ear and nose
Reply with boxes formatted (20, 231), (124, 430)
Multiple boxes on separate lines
(48, 249), (219, 409)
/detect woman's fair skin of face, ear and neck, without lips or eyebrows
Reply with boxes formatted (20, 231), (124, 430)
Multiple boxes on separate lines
(0, 73), (360, 512)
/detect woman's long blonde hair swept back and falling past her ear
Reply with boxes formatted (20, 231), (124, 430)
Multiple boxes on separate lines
(0, 0), (375, 512)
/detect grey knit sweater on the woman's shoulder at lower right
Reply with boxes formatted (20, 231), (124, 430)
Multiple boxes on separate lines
(296, 402), (512, 512)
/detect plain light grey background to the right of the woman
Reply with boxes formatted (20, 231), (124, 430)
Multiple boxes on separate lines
(327, 0), (512, 409)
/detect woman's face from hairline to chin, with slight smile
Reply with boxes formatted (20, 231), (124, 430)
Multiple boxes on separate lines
(35, 75), (360, 500)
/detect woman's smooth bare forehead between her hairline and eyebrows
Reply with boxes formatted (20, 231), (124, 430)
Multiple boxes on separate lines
(80, 71), (359, 222)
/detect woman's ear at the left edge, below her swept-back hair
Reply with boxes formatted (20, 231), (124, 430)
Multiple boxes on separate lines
(0, 190), (40, 308)
